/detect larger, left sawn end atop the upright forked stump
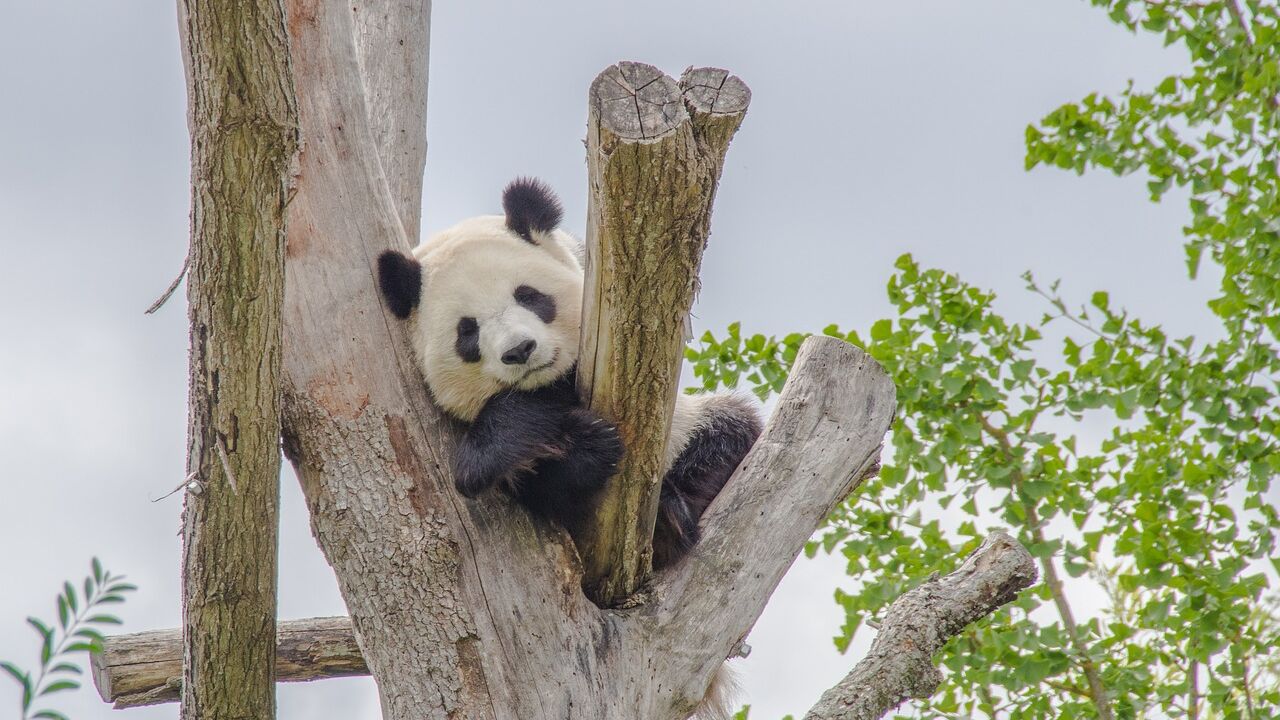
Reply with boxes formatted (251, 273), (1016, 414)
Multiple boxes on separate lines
(590, 61), (689, 141)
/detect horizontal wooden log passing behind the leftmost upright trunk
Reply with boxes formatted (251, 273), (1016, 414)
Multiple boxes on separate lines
(90, 618), (369, 710)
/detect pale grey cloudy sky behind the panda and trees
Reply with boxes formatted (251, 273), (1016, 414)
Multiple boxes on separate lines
(0, 0), (1215, 720)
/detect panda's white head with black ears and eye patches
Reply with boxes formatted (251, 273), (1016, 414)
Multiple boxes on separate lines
(378, 179), (582, 421)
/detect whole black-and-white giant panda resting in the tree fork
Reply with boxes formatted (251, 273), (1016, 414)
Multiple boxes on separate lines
(378, 179), (760, 569)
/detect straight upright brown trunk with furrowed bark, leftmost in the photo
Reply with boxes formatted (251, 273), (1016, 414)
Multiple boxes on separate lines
(179, 0), (298, 720)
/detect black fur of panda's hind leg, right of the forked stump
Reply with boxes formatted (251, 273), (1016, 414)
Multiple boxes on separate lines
(653, 398), (762, 570)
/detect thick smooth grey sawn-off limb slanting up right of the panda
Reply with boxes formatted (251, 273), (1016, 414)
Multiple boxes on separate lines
(650, 336), (896, 697)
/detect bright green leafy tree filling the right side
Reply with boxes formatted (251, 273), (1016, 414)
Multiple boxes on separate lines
(690, 0), (1280, 719)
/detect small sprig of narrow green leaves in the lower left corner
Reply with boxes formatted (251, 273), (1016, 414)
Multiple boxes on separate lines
(0, 557), (137, 720)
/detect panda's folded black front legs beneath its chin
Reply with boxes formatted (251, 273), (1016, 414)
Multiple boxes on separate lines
(453, 373), (623, 529)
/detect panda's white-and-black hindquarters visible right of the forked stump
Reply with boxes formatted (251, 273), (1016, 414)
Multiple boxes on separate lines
(653, 393), (763, 570)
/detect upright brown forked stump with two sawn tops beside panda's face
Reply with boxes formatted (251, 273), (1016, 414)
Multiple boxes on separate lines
(579, 63), (750, 606)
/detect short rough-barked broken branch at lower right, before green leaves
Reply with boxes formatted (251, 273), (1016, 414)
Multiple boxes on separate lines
(805, 533), (1037, 720)
